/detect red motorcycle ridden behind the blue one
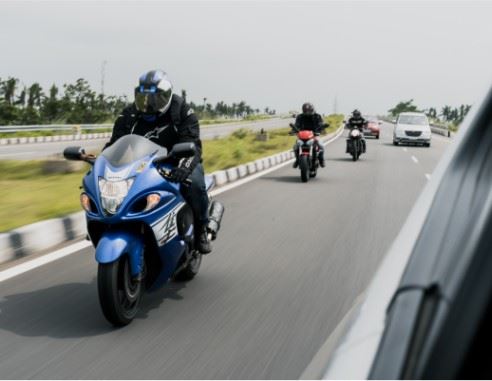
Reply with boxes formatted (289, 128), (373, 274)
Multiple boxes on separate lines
(291, 125), (319, 183)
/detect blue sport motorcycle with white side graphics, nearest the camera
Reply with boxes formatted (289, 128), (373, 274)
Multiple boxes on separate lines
(63, 135), (224, 326)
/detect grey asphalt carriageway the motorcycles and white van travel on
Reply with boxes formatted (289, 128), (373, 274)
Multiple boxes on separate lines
(0, 124), (449, 379)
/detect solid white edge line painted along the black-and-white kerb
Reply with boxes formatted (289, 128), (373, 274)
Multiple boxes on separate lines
(0, 128), (343, 282)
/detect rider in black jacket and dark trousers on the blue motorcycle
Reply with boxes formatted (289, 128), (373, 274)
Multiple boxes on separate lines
(104, 70), (212, 254)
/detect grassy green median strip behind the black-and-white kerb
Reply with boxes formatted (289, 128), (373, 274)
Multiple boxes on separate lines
(0, 116), (343, 232)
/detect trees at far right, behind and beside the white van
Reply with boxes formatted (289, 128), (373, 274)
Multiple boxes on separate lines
(388, 99), (471, 126)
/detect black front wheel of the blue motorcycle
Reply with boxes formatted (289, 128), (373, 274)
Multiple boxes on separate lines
(97, 255), (142, 327)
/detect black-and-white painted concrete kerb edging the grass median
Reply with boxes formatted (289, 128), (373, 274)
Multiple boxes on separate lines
(0, 125), (343, 264)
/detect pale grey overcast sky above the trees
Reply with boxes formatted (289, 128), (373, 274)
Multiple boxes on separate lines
(0, 0), (492, 113)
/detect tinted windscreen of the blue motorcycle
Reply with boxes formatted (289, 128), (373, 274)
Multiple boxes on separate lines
(101, 135), (167, 167)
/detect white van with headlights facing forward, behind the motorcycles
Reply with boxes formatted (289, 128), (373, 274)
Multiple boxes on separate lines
(393, 112), (432, 147)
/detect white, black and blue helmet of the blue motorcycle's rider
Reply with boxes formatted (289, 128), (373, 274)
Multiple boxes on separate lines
(135, 70), (173, 115)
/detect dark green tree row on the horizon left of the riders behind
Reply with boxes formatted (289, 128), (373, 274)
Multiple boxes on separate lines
(0, 77), (275, 125)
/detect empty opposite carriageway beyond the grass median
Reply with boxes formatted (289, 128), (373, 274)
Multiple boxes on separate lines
(0, 118), (293, 160)
